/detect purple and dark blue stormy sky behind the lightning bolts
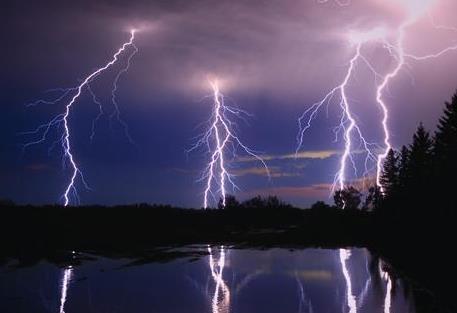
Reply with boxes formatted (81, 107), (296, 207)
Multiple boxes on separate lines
(0, 0), (457, 207)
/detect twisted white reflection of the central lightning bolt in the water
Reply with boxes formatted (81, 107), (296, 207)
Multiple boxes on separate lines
(208, 246), (230, 313)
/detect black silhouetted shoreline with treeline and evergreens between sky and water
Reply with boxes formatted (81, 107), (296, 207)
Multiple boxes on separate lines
(0, 95), (457, 312)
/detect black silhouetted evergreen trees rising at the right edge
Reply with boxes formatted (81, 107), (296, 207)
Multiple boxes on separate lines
(378, 93), (457, 214)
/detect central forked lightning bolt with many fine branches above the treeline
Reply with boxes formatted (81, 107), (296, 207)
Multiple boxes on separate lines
(187, 81), (270, 209)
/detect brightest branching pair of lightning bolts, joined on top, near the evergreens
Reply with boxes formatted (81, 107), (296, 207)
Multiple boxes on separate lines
(296, 0), (457, 193)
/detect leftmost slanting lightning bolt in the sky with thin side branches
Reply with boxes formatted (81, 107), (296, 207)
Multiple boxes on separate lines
(23, 29), (138, 206)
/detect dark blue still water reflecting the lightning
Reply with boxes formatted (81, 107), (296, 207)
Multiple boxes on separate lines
(0, 247), (415, 313)
